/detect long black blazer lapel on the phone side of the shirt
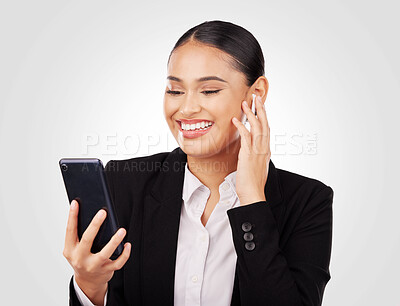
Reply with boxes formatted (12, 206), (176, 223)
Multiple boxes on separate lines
(141, 147), (187, 305)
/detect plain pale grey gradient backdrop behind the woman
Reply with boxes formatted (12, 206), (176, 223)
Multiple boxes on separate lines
(0, 0), (400, 306)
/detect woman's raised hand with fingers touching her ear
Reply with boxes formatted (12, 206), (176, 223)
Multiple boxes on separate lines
(232, 96), (271, 205)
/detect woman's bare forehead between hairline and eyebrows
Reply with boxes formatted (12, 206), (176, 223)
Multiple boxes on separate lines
(168, 42), (244, 82)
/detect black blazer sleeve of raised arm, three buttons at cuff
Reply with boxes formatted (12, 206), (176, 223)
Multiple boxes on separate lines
(227, 186), (333, 306)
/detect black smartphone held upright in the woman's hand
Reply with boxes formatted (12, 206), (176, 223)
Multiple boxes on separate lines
(59, 158), (124, 259)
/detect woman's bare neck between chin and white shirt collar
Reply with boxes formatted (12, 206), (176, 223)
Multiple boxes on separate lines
(187, 138), (240, 191)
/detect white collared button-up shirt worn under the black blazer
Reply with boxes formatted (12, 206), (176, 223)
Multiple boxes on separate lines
(74, 163), (240, 306)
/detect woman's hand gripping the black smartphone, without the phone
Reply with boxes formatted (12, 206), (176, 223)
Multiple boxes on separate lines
(63, 200), (131, 305)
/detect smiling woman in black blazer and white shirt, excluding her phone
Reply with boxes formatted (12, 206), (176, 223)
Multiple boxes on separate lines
(64, 21), (333, 306)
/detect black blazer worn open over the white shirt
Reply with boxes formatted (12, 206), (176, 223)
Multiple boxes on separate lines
(69, 147), (333, 306)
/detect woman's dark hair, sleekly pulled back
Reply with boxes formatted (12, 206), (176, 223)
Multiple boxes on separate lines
(168, 20), (264, 86)
